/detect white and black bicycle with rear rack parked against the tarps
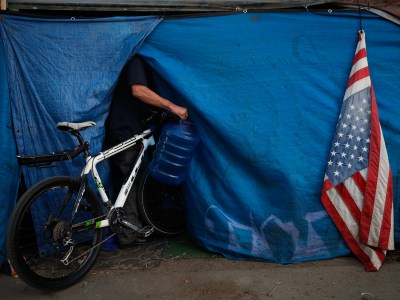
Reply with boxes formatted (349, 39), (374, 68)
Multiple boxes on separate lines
(7, 111), (184, 290)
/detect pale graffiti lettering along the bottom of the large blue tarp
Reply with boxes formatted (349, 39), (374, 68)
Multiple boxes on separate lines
(205, 205), (329, 262)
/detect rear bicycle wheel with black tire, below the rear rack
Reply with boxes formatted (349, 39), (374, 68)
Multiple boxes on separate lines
(7, 176), (104, 290)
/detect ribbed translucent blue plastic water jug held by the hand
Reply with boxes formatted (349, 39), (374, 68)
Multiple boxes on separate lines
(149, 120), (200, 185)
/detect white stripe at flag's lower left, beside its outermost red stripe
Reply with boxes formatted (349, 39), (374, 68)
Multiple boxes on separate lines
(327, 189), (382, 270)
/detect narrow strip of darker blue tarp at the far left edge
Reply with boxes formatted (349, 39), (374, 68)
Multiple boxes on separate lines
(0, 31), (19, 265)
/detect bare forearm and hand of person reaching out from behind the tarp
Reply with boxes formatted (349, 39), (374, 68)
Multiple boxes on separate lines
(131, 84), (188, 120)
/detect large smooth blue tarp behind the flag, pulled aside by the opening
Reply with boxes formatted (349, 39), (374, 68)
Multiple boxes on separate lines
(139, 12), (400, 263)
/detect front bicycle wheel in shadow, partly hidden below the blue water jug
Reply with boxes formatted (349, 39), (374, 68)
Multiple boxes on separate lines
(138, 164), (186, 235)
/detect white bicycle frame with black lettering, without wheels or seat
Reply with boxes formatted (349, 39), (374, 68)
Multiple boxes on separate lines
(80, 129), (155, 228)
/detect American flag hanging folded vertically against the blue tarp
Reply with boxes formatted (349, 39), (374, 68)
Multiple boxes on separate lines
(321, 30), (394, 271)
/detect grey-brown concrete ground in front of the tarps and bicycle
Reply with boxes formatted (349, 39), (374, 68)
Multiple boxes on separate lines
(0, 254), (400, 300)
